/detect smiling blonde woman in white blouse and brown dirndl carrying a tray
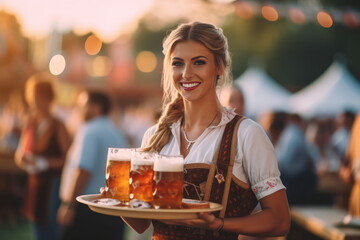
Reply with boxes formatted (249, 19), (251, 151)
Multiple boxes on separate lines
(124, 22), (290, 239)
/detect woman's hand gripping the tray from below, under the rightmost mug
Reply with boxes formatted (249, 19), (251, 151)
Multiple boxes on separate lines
(161, 213), (223, 230)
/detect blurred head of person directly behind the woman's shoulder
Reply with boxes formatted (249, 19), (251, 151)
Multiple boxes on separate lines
(220, 83), (245, 116)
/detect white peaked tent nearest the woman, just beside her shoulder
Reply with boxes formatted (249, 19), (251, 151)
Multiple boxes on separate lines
(235, 67), (291, 117)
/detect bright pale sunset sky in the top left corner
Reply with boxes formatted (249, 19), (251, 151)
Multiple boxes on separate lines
(0, 0), (153, 38)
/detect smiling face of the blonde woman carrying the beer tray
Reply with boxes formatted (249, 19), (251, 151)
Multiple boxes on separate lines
(171, 41), (219, 101)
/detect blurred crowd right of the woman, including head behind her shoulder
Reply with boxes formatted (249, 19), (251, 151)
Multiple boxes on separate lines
(220, 85), (360, 212)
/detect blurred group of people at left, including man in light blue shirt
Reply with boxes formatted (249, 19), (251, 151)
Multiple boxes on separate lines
(0, 73), (158, 240)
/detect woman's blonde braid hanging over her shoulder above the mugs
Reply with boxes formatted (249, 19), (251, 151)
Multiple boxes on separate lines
(143, 96), (184, 152)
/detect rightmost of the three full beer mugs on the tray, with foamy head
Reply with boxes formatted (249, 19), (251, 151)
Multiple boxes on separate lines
(153, 155), (184, 209)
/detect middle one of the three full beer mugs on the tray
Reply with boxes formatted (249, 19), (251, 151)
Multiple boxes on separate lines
(129, 150), (157, 203)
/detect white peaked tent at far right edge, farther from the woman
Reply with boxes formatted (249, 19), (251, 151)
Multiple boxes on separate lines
(290, 62), (360, 118)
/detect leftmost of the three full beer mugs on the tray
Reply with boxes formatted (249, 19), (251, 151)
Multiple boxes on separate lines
(105, 148), (134, 205)
